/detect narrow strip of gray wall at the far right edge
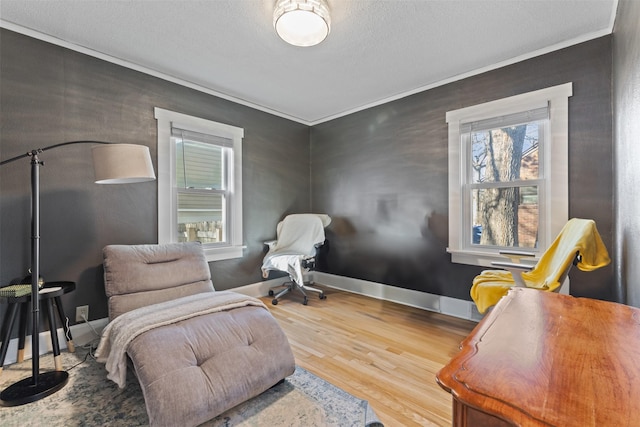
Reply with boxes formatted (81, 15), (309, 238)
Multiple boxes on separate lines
(613, 0), (640, 307)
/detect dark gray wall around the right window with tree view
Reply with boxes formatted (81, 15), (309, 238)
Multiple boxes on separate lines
(311, 36), (613, 300)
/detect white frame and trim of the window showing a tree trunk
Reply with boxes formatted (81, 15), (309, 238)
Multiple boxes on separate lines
(446, 83), (573, 267)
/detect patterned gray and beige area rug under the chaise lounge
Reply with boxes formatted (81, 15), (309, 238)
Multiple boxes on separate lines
(0, 349), (382, 427)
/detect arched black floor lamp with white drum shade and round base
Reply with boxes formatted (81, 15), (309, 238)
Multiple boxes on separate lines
(0, 141), (156, 406)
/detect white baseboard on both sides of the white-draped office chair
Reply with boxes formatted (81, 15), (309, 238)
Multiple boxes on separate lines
(232, 271), (483, 322)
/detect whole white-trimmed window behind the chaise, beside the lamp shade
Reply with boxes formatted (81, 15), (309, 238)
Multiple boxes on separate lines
(155, 108), (244, 261)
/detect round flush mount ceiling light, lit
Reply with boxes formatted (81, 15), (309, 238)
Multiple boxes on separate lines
(273, 0), (331, 47)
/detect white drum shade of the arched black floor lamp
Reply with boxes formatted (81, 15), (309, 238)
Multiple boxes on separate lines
(92, 144), (156, 184)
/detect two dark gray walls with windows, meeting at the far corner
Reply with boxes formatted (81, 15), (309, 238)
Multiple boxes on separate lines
(0, 30), (613, 336)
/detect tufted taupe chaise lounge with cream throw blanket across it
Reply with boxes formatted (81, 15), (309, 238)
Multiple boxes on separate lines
(98, 243), (295, 426)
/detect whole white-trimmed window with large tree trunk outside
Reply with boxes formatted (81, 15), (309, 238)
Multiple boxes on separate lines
(446, 83), (572, 266)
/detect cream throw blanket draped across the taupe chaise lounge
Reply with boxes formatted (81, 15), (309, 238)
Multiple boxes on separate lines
(96, 291), (267, 388)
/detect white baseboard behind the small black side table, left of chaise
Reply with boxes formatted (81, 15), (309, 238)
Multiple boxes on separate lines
(4, 318), (109, 366)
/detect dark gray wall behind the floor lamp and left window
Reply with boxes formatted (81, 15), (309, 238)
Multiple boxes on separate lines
(0, 29), (310, 326)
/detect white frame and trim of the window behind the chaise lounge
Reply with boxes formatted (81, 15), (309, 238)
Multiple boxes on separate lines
(154, 107), (245, 261)
